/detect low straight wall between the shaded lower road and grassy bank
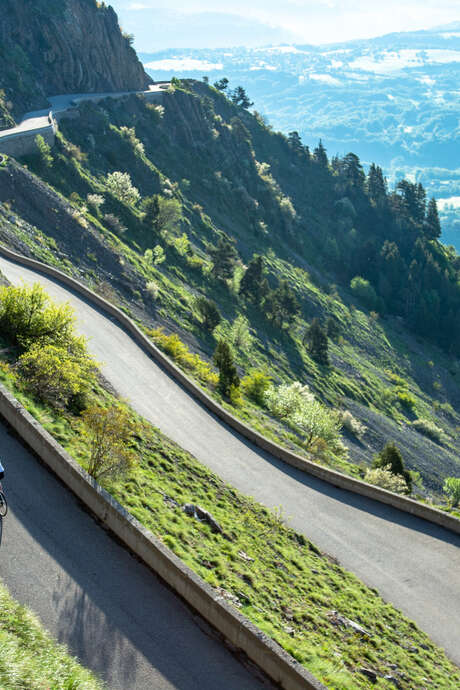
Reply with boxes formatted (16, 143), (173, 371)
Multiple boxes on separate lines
(0, 385), (325, 690)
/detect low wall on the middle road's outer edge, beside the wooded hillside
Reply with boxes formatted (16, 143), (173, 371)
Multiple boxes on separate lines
(0, 245), (460, 534)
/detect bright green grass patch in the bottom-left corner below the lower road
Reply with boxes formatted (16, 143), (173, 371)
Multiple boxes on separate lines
(0, 583), (105, 690)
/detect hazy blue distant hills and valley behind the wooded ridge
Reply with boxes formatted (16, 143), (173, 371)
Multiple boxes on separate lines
(141, 22), (460, 250)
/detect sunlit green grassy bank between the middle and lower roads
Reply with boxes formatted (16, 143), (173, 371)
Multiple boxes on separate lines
(0, 350), (460, 690)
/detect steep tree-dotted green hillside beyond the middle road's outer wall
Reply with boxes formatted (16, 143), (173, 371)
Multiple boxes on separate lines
(0, 82), (460, 492)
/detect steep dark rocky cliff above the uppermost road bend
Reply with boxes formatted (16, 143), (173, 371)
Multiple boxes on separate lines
(0, 0), (151, 129)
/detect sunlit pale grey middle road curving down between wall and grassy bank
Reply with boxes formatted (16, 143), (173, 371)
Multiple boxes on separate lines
(0, 258), (460, 665)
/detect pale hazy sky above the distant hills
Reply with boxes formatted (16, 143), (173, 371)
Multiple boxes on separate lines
(108, 0), (460, 52)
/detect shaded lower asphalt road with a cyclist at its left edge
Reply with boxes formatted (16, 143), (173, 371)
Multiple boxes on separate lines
(0, 424), (264, 690)
